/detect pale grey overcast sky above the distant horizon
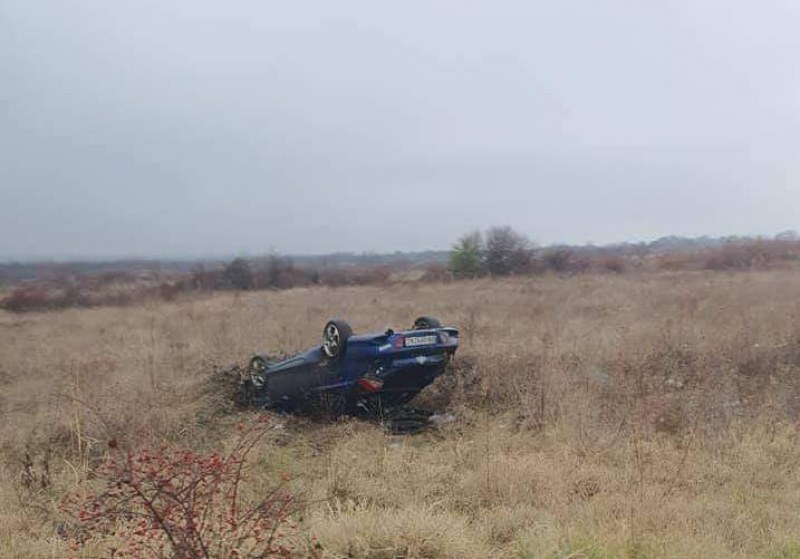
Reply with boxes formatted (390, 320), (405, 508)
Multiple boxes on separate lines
(0, 0), (800, 260)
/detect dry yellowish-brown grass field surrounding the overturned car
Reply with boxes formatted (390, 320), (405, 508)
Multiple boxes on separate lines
(0, 269), (800, 559)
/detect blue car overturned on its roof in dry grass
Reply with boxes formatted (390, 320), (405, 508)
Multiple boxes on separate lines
(242, 316), (458, 414)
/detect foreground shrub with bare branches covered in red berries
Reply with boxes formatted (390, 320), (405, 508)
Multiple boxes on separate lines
(63, 416), (293, 559)
